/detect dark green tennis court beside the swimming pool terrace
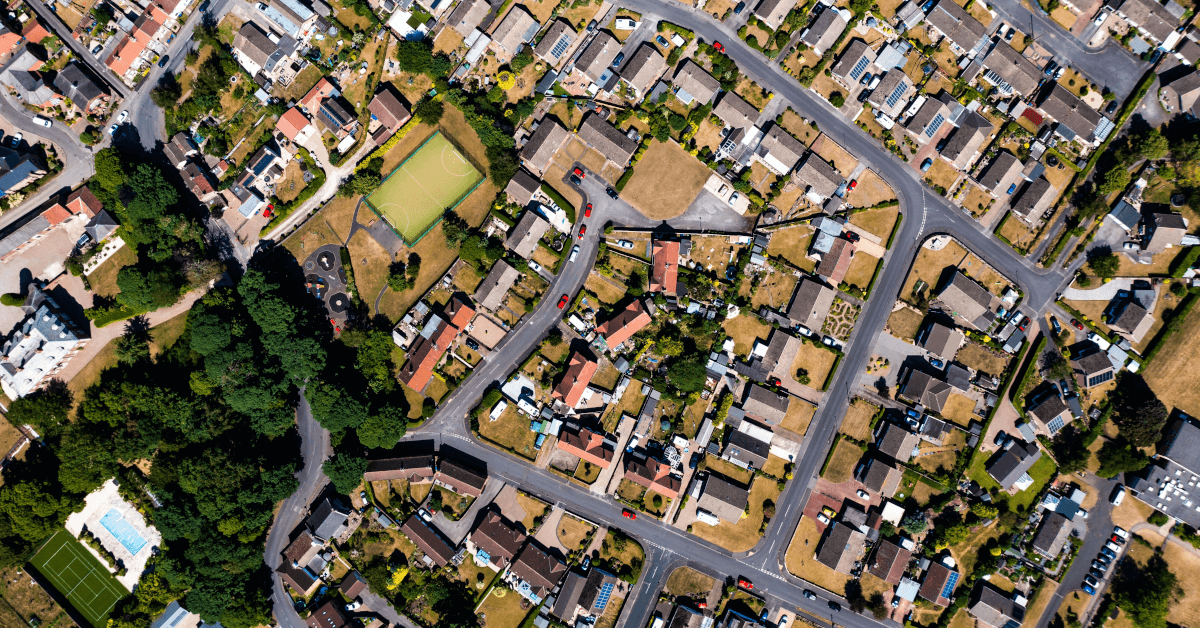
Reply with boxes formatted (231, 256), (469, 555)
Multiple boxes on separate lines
(29, 530), (130, 628)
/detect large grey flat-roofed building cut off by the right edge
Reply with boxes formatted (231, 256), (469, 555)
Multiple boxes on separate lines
(1126, 415), (1200, 527)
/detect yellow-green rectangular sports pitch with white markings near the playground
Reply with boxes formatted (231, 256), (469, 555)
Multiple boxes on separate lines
(367, 132), (484, 246)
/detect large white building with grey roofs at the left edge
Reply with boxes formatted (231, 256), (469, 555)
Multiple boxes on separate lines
(0, 283), (90, 399)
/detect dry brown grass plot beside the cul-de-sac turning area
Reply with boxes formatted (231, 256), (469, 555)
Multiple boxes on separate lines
(622, 140), (712, 220)
